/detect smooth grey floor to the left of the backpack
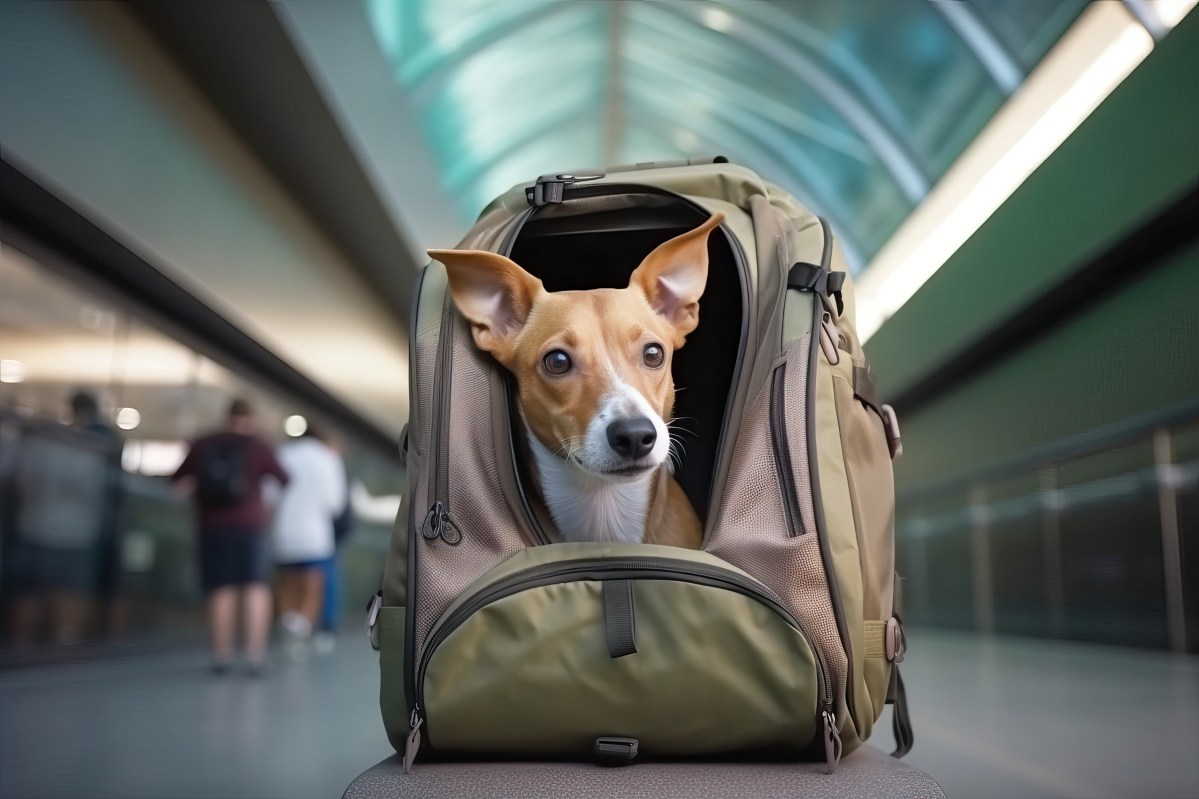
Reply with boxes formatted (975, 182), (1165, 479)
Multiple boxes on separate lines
(0, 635), (391, 799)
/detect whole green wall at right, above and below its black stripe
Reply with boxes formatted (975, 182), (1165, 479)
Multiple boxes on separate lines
(867, 13), (1199, 488)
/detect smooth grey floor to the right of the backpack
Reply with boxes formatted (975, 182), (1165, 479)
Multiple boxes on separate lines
(872, 631), (1199, 799)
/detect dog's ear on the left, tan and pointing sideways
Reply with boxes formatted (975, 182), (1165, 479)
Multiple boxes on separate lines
(429, 250), (544, 362)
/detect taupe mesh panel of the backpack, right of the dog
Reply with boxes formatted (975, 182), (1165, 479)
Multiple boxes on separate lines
(707, 335), (848, 697)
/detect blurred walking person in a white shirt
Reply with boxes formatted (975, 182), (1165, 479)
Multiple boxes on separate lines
(272, 419), (348, 657)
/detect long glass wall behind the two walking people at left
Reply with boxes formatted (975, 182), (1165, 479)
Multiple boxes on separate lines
(0, 246), (402, 666)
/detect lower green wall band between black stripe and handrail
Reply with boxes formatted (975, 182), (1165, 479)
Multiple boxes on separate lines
(896, 239), (1199, 487)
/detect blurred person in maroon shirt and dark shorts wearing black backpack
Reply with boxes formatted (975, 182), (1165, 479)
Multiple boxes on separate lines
(171, 400), (288, 674)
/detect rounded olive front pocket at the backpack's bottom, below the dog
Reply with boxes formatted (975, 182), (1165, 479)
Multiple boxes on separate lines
(418, 543), (831, 758)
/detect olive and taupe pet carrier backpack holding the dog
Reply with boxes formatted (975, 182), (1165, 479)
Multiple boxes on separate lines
(368, 158), (911, 771)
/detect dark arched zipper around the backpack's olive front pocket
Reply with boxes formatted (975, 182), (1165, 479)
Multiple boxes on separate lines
(417, 557), (840, 768)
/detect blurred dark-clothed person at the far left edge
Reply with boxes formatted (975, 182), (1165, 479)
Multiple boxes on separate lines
(6, 391), (122, 645)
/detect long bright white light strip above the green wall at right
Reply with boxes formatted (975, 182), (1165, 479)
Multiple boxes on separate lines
(857, 2), (1153, 342)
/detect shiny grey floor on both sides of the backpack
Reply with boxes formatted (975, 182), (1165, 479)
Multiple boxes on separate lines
(0, 631), (1199, 799)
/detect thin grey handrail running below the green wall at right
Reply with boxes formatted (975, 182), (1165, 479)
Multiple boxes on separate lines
(898, 398), (1199, 503)
